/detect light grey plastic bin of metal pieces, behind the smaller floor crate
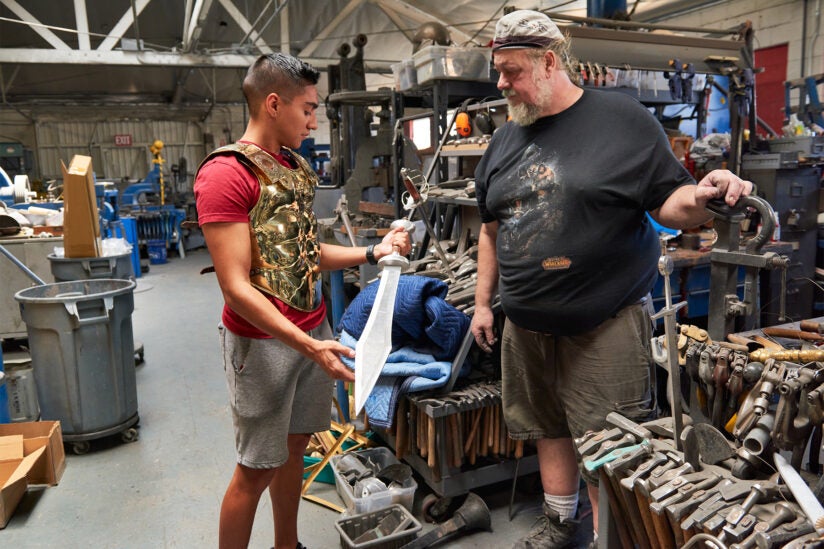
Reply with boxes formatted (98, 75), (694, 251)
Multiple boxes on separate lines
(329, 447), (418, 516)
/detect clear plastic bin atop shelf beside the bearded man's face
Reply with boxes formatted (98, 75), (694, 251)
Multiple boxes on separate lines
(412, 46), (491, 84)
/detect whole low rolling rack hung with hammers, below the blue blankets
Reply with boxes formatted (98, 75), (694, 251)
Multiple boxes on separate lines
(379, 380), (538, 497)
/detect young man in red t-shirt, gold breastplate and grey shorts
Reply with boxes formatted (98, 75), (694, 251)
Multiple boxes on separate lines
(195, 53), (410, 549)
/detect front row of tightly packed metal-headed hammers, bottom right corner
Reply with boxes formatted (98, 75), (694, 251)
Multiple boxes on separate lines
(575, 413), (820, 549)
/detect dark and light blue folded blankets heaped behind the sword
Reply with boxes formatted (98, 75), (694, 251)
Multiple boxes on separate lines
(337, 275), (470, 429)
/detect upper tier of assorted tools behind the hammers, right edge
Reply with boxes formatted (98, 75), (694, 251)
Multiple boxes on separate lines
(678, 326), (824, 479)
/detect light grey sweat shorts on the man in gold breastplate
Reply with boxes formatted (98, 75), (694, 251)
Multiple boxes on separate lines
(218, 321), (334, 469)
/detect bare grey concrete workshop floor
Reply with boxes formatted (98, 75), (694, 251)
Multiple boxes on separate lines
(0, 250), (591, 549)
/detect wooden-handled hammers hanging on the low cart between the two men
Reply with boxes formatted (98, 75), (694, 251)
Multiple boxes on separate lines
(393, 381), (524, 478)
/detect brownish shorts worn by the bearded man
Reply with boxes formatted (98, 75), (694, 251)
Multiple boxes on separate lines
(501, 304), (653, 483)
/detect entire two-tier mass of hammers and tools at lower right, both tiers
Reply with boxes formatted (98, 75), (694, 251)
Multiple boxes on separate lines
(575, 325), (824, 548)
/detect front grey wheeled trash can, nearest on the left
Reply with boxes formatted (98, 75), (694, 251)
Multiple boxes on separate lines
(14, 279), (139, 454)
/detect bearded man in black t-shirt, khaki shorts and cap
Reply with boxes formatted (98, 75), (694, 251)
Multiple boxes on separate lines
(471, 10), (752, 548)
